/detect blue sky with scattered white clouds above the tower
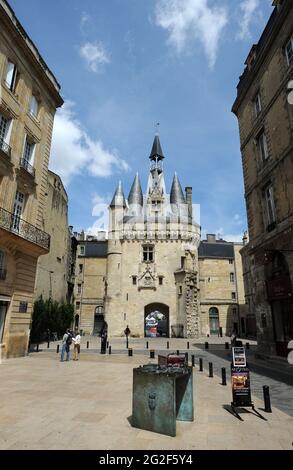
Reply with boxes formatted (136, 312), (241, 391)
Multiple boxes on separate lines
(10, 0), (272, 240)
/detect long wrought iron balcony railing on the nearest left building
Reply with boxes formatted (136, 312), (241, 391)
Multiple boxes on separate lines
(0, 207), (50, 250)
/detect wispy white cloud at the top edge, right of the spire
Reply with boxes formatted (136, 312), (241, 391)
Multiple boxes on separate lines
(156, 0), (228, 68)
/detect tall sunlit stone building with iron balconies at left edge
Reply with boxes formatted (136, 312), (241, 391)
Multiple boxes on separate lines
(0, 0), (63, 357)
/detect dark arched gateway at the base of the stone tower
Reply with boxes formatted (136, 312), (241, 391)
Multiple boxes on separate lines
(144, 303), (170, 338)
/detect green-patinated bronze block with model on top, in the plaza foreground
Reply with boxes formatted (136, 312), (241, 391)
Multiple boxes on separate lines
(131, 364), (194, 437)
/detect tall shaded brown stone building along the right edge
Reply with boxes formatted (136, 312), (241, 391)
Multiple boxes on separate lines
(233, 0), (293, 356)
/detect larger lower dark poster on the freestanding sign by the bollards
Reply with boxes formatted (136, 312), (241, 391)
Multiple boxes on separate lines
(231, 366), (251, 406)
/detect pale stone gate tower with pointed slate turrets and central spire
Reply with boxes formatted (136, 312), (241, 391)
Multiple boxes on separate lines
(105, 135), (200, 337)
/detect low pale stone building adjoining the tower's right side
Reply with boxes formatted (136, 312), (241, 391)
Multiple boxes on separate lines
(198, 235), (248, 337)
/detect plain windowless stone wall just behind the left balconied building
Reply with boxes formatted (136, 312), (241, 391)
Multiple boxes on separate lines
(35, 170), (71, 302)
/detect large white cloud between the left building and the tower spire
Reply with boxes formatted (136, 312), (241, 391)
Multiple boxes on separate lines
(50, 102), (128, 185)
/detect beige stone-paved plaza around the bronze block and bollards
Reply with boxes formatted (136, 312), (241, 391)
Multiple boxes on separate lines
(0, 338), (293, 450)
